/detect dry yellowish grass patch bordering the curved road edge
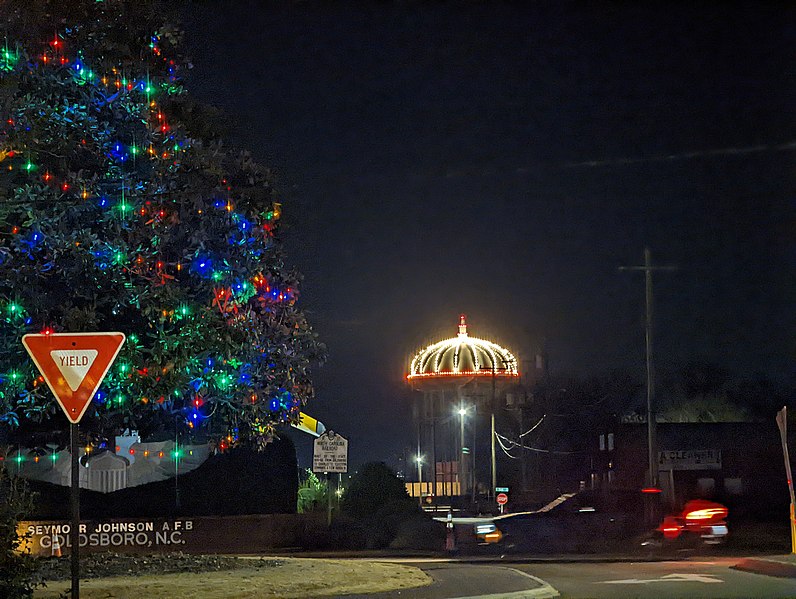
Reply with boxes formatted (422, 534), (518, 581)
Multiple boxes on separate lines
(34, 557), (431, 599)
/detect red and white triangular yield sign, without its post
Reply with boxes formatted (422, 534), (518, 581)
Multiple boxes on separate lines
(22, 333), (124, 424)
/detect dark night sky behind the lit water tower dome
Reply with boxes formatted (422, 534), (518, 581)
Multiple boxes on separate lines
(186, 0), (796, 466)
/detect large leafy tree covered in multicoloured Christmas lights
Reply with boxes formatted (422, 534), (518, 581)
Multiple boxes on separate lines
(0, 0), (323, 447)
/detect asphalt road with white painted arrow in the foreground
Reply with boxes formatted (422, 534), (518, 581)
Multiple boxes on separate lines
(357, 558), (796, 599)
